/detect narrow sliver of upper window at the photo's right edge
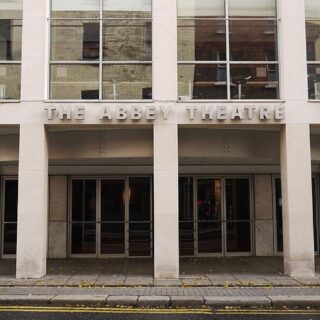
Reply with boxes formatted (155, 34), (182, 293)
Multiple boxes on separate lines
(305, 0), (320, 100)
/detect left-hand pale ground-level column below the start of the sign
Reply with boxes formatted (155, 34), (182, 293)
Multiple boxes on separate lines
(16, 124), (48, 278)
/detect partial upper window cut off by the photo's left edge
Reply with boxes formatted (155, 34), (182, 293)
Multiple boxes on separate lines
(0, 0), (22, 100)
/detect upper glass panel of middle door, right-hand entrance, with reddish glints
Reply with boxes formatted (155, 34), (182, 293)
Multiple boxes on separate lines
(197, 179), (221, 221)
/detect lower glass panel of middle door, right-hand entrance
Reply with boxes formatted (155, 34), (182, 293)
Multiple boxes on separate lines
(198, 222), (222, 253)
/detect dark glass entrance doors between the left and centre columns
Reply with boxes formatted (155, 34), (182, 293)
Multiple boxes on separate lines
(69, 177), (153, 258)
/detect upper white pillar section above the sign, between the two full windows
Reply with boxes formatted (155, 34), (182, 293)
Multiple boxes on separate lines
(152, 0), (178, 101)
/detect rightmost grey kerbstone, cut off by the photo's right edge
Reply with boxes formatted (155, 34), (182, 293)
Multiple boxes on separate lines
(269, 295), (320, 308)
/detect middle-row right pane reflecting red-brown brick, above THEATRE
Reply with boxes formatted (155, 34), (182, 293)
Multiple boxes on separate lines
(230, 20), (278, 61)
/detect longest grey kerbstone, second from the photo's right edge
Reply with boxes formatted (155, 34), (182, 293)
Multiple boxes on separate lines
(204, 296), (271, 307)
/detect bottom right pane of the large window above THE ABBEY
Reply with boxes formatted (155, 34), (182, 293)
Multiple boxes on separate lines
(103, 64), (152, 100)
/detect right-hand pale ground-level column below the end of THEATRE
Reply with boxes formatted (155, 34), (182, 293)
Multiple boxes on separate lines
(280, 124), (315, 277)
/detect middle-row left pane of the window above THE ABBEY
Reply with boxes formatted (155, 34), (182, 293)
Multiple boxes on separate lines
(51, 20), (99, 61)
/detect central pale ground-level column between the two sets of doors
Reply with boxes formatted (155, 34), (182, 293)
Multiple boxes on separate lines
(153, 124), (179, 279)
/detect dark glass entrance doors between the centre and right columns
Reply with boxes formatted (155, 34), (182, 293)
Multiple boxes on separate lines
(179, 177), (252, 256)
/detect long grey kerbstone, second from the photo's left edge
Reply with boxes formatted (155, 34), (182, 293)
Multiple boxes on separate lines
(51, 295), (107, 307)
